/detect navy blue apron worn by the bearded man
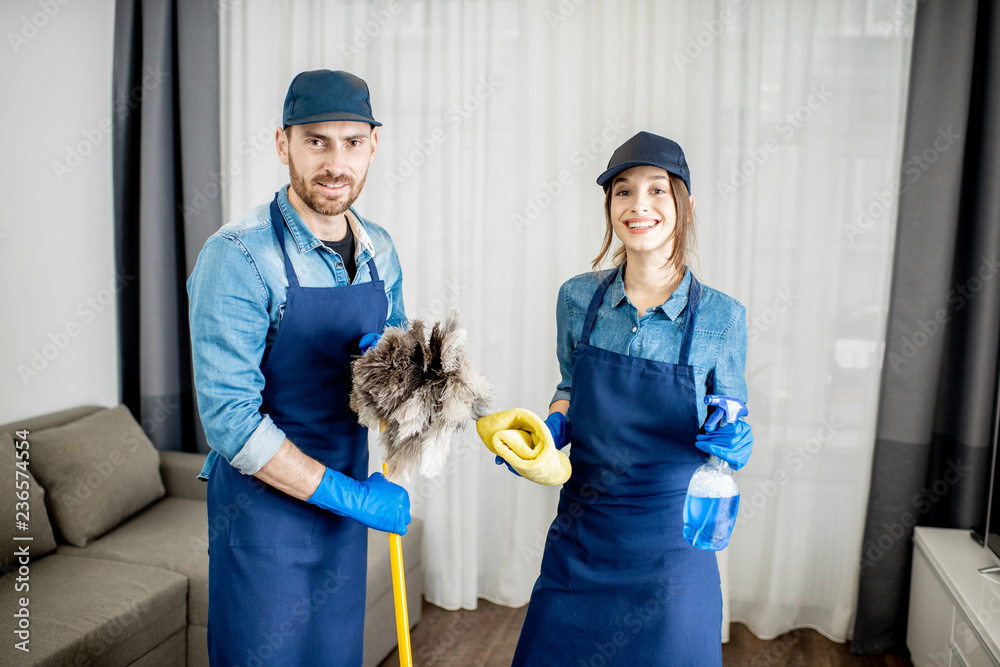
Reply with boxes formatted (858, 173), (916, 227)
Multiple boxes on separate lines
(208, 197), (388, 667)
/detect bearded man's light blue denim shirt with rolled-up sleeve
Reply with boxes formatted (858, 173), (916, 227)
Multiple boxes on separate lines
(187, 185), (406, 479)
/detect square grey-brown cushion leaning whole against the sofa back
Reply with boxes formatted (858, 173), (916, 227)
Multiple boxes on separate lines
(30, 405), (164, 547)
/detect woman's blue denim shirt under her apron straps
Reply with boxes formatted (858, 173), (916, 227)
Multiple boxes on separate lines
(552, 270), (747, 424)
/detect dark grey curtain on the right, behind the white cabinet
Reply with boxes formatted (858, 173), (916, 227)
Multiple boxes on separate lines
(852, 0), (1000, 654)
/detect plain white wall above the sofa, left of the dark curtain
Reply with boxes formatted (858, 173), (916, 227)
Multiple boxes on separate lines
(0, 0), (119, 423)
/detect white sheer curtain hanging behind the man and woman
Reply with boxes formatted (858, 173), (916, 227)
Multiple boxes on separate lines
(220, 0), (914, 640)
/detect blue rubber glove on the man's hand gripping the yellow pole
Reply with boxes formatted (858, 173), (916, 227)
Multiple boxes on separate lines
(306, 468), (410, 535)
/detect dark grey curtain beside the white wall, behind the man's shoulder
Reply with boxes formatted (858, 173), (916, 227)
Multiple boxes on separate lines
(113, 0), (222, 451)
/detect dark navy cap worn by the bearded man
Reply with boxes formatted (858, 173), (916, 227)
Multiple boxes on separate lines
(281, 69), (382, 127)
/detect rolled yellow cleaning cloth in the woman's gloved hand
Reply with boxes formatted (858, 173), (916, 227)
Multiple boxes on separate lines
(476, 408), (573, 486)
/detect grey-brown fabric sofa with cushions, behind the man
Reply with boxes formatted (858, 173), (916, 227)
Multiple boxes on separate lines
(0, 406), (423, 667)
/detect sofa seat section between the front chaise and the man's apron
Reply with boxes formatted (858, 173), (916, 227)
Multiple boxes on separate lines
(57, 497), (208, 625)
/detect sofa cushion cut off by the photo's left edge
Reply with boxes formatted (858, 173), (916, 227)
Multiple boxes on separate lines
(0, 432), (56, 570)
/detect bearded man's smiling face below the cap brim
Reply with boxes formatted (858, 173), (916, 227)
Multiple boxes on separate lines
(275, 120), (378, 217)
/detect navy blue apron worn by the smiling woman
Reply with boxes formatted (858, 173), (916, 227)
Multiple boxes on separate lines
(513, 271), (722, 667)
